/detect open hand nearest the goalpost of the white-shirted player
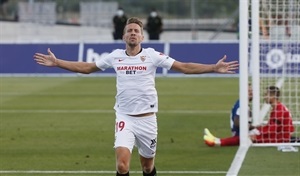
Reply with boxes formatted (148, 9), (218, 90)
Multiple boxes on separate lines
(214, 55), (239, 73)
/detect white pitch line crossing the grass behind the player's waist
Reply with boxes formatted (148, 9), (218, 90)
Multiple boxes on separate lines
(0, 109), (229, 114)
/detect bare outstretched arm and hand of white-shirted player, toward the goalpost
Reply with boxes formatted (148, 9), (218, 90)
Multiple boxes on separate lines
(172, 55), (239, 74)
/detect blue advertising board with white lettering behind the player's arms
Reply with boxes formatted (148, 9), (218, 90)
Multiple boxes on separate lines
(0, 42), (300, 75)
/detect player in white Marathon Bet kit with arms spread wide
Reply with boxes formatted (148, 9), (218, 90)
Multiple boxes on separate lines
(34, 17), (238, 176)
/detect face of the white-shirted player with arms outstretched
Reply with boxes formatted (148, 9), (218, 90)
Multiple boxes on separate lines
(123, 23), (144, 47)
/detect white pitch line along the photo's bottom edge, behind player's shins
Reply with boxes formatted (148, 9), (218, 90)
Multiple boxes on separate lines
(0, 170), (227, 175)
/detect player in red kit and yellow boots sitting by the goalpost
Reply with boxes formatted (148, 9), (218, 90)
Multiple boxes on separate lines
(204, 86), (300, 146)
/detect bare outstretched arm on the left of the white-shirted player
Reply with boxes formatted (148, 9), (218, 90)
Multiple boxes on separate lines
(33, 48), (100, 74)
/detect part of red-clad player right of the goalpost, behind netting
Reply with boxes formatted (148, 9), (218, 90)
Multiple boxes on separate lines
(250, 86), (295, 143)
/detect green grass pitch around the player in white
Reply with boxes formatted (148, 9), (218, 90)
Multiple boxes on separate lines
(0, 77), (300, 176)
